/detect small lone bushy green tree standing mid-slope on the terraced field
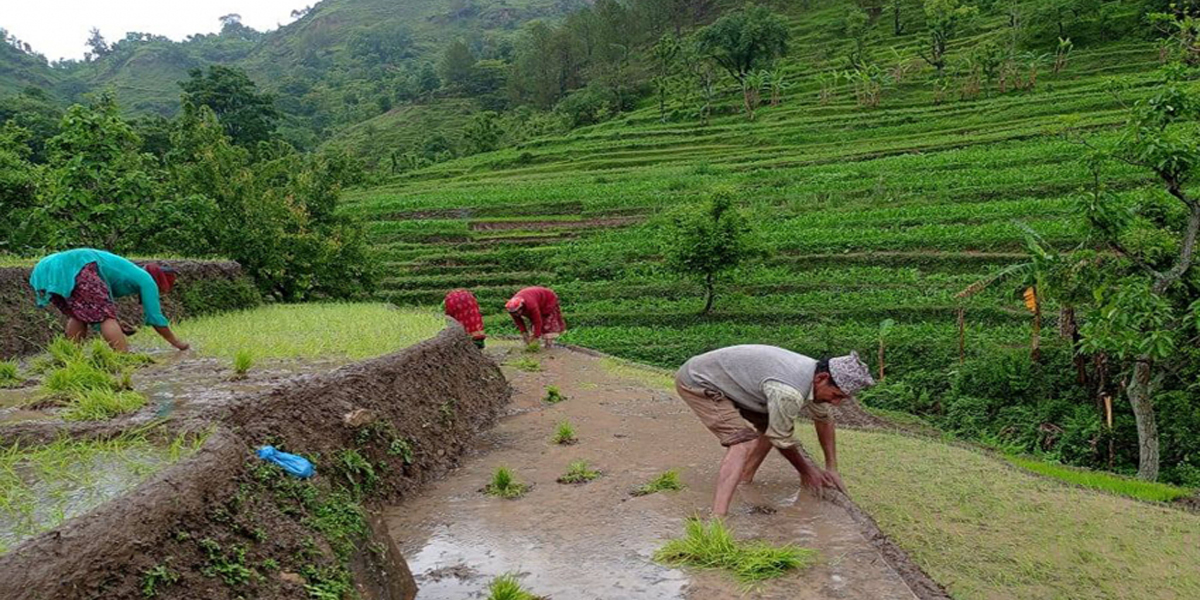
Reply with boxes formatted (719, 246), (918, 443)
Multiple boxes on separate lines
(662, 190), (762, 314)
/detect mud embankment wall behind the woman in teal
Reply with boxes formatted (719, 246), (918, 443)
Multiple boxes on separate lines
(0, 260), (259, 359)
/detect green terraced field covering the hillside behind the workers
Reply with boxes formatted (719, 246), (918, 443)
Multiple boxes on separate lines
(347, 17), (1157, 379)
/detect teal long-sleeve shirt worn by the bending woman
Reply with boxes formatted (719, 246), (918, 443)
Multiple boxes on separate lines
(29, 248), (169, 328)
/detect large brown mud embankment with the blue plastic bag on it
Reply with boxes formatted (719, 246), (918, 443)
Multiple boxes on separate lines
(0, 325), (510, 600)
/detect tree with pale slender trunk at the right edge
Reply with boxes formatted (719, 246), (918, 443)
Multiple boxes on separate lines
(1080, 64), (1200, 480)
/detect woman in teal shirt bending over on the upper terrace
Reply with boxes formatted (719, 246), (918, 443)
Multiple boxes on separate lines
(29, 248), (188, 352)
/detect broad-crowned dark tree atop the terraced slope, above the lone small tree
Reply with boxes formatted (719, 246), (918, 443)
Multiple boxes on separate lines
(696, 5), (791, 116)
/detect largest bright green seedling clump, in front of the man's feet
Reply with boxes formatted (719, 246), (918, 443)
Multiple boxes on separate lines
(654, 517), (816, 584)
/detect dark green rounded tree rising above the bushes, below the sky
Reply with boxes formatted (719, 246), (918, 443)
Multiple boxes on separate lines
(179, 65), (280, 148)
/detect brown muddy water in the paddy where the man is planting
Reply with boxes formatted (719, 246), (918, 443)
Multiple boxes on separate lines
(385, 349), (914, 600)
